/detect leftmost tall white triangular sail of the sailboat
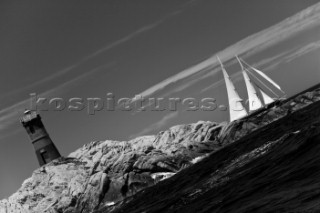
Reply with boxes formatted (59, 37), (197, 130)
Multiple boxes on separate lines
(217, 56), (248, 122)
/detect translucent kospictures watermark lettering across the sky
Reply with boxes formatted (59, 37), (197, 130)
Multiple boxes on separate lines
(30, 93), (243, 115)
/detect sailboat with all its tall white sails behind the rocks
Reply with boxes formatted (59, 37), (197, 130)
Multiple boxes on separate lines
(217, 56), (284, 122)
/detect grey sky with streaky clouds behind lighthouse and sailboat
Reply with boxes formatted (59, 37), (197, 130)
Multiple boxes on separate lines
(0, 0), (320, 198)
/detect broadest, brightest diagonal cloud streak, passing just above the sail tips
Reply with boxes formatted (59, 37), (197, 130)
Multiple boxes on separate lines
(133, 3), (320, 101)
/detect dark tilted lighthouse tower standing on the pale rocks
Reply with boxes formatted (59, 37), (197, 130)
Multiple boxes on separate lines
(20, 110), (61, 166)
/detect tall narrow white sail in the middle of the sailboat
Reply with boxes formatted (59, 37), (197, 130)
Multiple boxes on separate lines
(236, 56), (263, 112)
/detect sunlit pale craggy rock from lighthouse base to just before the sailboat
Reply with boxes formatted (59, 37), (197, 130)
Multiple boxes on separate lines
(0, 121), (226, 213)
